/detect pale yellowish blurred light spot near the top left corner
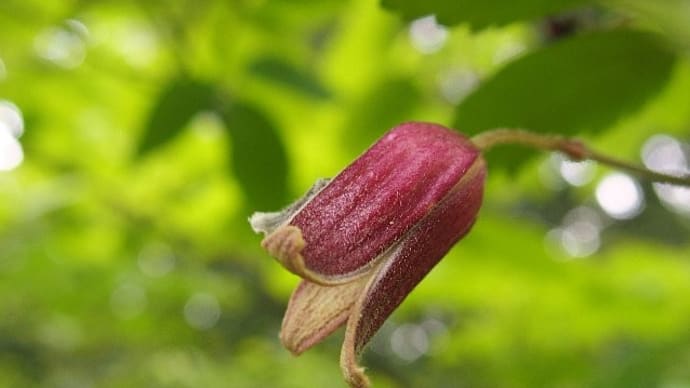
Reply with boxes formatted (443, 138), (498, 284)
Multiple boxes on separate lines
(34, 19), (89, 69)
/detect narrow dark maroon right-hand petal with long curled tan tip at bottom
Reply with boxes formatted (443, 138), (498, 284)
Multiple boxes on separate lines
(340, 159), (486, 387)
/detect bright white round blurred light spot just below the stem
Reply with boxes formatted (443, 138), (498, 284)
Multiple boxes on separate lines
(596, 173), (644, 220)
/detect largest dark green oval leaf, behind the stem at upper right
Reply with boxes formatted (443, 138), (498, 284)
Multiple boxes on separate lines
(453, 30), (675, 168)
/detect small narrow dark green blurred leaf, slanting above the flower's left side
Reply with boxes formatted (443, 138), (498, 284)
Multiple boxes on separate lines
(249, 57), (331, 99)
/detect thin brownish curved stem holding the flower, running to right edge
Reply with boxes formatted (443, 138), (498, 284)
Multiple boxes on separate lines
(472, 128), (690, 186)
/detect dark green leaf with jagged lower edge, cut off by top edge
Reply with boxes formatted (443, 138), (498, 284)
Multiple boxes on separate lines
(381, 0), (593, 29)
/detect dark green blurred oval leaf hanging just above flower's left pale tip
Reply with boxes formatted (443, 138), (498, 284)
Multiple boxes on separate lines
(222, 102), (288, 210)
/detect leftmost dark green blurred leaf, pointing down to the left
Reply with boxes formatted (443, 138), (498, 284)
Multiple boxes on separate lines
(137, 77), (216, 156)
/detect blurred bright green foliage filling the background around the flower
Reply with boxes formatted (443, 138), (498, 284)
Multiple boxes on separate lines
(0, 0), (690, 387)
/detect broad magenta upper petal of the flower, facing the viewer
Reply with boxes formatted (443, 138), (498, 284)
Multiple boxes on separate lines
(289, 122), (479, 283)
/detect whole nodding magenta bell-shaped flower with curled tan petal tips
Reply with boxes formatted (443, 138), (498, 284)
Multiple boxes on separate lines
(250, 122), (486, 387)
